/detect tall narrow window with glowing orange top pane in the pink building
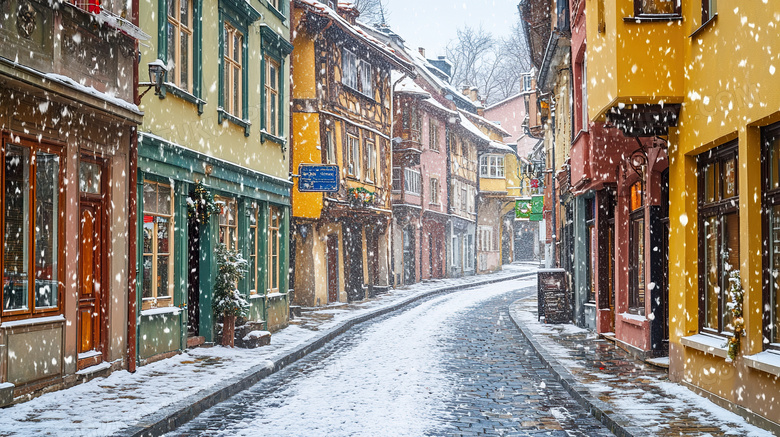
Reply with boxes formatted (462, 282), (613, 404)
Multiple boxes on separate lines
(628, 180), (646, 315)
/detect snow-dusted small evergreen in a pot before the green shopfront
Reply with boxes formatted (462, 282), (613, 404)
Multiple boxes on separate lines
(212, 244), (249, 347)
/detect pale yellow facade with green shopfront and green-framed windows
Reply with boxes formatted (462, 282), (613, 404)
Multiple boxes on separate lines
(137, 0), (292, 363)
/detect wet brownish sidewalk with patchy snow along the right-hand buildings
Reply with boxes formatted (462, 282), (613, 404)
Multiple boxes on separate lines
(509, 295), (773, 436)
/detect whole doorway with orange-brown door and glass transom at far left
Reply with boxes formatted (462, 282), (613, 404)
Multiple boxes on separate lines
(76, 156), (108, 370)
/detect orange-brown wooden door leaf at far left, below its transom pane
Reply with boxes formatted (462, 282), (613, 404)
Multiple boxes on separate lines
(77, 198), (105, 369)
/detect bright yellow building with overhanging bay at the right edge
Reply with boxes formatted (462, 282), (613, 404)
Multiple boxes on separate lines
(587, 0), (780, 432)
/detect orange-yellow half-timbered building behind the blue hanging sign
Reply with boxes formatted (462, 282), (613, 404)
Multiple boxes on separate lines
(291, 0), (411, 306)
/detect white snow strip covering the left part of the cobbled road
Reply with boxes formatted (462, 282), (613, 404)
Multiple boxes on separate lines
(178, 278), (536, 436)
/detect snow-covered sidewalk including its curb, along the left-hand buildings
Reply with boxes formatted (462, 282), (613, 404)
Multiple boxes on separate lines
(0, 264), (538, 436)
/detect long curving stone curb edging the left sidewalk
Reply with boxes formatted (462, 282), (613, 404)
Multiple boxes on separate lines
(115, 272), (536, 437)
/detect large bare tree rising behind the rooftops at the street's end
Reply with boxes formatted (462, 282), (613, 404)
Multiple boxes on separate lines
(447, 14), (531, 105)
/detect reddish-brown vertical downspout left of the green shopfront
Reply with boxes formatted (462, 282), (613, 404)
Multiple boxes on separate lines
(127, 0), (141, 373)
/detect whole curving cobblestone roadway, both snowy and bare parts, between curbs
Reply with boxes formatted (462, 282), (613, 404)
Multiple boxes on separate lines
(171, 281), (612, 436)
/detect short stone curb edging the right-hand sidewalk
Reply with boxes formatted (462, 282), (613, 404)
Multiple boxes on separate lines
(509, 298), (647, 437)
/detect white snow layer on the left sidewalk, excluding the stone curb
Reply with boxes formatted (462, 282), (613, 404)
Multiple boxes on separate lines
(0, 264), (536, 436)
